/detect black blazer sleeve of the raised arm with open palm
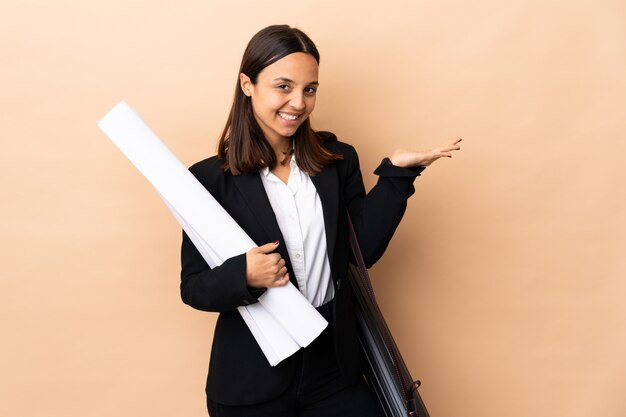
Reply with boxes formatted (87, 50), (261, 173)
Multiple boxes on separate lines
(344, 146), (425, 268)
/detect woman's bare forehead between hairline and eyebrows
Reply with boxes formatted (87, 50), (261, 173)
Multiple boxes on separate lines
(259, 52), (319, 84)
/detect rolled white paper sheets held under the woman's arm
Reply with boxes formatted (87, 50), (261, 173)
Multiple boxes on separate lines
(98, 101), (328, 366)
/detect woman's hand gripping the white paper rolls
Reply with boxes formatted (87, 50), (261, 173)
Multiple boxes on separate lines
(246, 241), (289, 288)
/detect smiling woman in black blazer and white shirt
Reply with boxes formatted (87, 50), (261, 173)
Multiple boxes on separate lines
(181, 25), (460, 417)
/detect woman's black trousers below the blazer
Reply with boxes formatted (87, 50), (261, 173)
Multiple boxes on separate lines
(207, 301), (382, 417)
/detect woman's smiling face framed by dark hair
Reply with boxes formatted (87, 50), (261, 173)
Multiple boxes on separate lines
(240, 52), (319, 144)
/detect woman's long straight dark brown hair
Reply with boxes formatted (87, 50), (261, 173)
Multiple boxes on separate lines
(217, 25), (342, 175)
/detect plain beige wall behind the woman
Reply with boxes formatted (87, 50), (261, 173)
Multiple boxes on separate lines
(0, 0), (626, 417)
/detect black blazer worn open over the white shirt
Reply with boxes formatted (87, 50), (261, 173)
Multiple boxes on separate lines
(180, 132), (423, 405)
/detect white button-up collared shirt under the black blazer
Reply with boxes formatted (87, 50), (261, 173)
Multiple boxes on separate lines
(259, 155), (335, 307)
